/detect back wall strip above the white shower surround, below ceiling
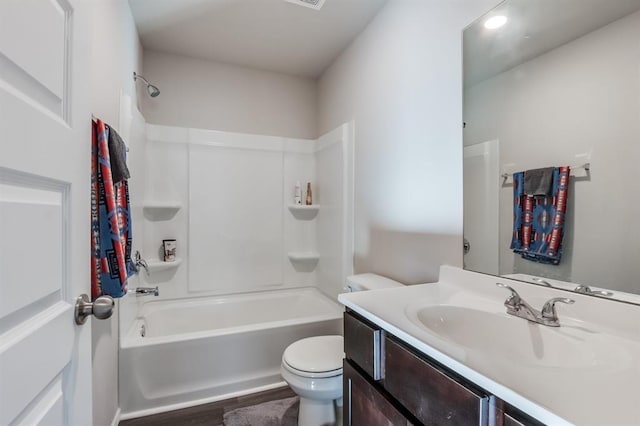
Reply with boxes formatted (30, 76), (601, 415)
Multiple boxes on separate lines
(141, 50), (317, 139)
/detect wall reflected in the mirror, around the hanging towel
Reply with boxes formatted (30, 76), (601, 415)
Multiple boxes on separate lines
(465, 12), (640, 292)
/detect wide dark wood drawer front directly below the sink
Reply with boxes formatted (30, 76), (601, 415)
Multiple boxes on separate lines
(383, 337), (489, 426)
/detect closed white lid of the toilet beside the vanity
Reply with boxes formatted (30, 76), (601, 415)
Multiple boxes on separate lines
(282, 336), (344, 373)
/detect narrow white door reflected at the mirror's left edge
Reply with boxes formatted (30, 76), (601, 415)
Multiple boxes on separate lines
(464, 140), (500, 275)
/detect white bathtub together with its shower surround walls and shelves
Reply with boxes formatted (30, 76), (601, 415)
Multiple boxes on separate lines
(119, 116), (353, 419)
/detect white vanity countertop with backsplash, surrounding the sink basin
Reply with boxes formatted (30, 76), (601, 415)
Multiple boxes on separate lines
(338, 266), (640, 426)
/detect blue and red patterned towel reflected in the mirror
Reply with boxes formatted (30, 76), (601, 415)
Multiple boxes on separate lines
(511, 166), (570, 265)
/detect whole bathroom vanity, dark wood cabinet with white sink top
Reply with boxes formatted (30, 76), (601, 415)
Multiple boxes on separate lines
(339, 266), (640, 425)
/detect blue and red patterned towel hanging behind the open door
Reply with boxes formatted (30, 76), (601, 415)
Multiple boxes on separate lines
(91, 120), (135, 299)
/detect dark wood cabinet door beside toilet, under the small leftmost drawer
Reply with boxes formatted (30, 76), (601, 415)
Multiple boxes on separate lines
(343, 361), (413, 426)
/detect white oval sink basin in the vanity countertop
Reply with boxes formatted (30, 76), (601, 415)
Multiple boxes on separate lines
(407, 305), (620, 368)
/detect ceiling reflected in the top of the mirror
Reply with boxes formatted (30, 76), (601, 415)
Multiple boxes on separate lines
(463, 0), (640, 87)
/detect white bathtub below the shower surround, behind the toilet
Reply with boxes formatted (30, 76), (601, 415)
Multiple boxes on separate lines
(119, 288), (343, 419)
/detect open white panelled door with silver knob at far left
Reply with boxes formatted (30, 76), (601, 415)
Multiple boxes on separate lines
(0, 0), (92, 426)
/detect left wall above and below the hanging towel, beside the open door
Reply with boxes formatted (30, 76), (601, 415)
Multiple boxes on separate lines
(84, 0), (142, 426)
